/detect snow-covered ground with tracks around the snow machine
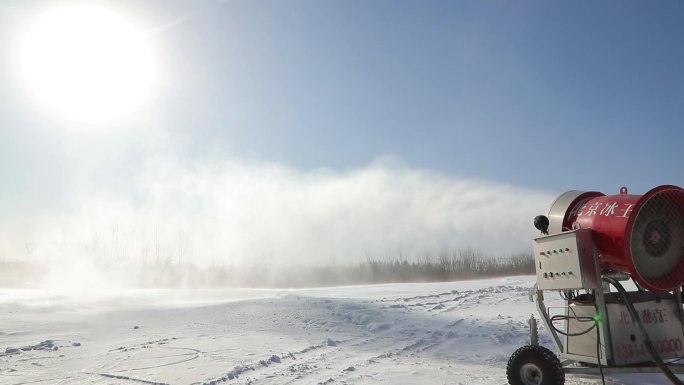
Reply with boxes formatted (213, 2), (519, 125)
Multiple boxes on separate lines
(0, 276), (680, 385)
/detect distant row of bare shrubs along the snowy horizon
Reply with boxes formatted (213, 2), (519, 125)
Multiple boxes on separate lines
(0, 249), (534, 288)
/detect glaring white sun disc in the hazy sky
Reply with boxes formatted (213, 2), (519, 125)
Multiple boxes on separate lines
(18, 5), (154, 121)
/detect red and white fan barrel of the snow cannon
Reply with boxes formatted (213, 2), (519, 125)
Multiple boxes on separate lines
(540, 185), (684, 293)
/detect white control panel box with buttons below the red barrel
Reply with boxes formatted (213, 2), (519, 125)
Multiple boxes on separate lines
(533, 229), (600, 290)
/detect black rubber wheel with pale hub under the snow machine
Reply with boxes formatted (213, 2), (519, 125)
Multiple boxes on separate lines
(506, 345), (565, 385)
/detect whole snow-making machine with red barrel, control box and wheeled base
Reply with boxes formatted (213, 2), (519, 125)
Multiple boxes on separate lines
(506, 185), (684, 385)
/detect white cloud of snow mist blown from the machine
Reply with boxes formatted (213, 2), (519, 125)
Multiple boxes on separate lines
(0, 154), (554, 266)
